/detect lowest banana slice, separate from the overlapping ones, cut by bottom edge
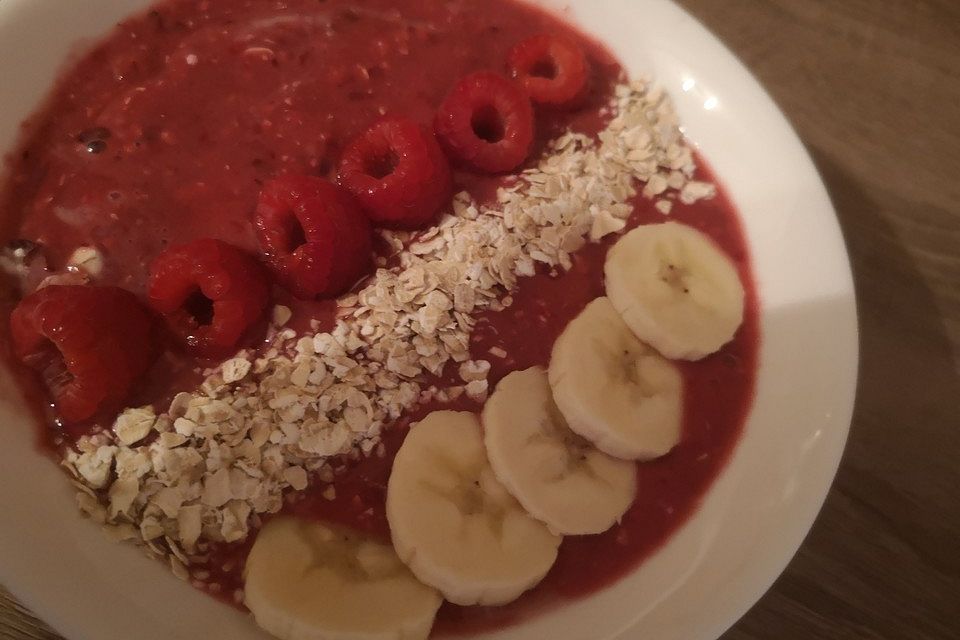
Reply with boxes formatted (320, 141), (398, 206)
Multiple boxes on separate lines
(244, 518), (442, 640)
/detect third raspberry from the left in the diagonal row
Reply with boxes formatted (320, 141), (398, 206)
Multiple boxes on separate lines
(254, 175), (373, 299)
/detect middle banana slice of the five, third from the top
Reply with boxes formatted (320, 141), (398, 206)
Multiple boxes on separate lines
(483, 367), (637, 535)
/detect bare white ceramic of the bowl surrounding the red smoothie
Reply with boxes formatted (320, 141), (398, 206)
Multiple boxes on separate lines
(0, 0), (857, 640)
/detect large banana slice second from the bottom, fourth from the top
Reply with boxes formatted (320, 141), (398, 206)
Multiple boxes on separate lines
(387, 411), (561, 605)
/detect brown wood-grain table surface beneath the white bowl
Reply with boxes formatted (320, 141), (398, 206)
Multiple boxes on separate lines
(0, 0), (960, 640)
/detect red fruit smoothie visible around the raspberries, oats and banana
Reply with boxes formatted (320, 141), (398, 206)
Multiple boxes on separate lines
(0, 0), (760, 635)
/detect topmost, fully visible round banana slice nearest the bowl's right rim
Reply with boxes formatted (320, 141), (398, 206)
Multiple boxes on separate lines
(604, 222), (744, 360)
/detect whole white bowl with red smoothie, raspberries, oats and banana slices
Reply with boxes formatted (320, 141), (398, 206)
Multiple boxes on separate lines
(0, 0), (856, 639)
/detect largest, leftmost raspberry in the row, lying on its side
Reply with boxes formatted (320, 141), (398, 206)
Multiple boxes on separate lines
(10, 285), (160, 424)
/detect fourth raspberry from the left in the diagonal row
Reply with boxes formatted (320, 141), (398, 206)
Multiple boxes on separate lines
(338, 117), (453, 229)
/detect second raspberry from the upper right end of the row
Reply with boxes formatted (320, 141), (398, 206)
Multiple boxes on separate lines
(434, 71), (533, 173)
